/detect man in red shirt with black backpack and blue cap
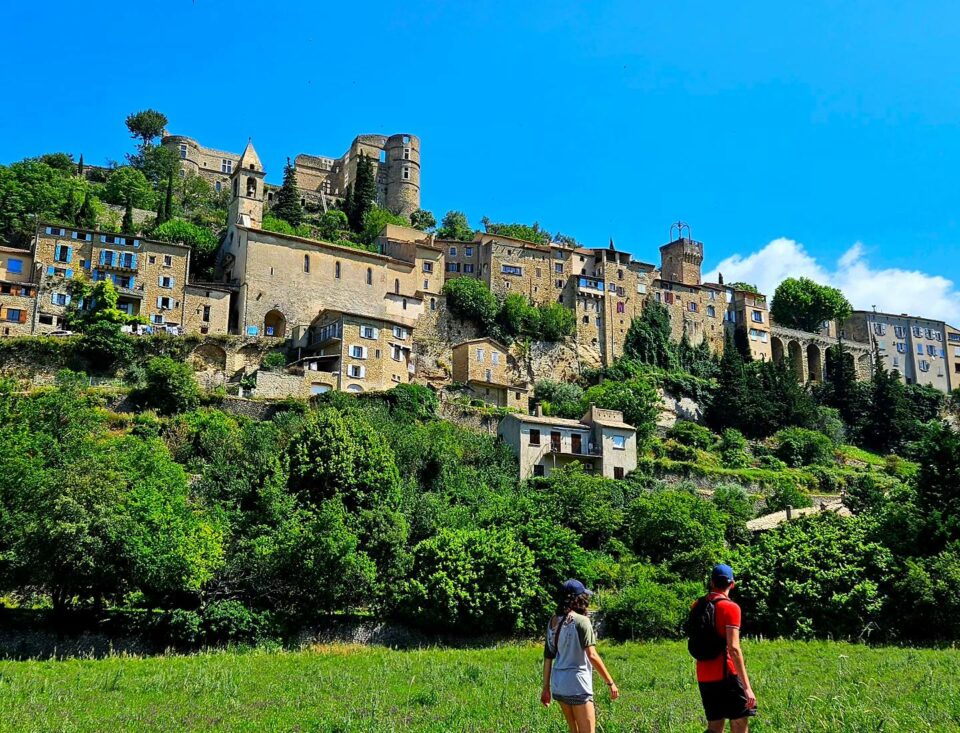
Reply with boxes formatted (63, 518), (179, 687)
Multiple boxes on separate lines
(687, 565), (757, 733)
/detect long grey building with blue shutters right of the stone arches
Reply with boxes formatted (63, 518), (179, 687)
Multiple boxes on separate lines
(843, 310), (954, 392)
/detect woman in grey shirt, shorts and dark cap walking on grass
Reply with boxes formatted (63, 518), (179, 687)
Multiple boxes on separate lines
(540, 580), (620, 733)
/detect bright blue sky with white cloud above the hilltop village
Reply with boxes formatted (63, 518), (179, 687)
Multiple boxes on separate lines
(0, 0), (960, 321)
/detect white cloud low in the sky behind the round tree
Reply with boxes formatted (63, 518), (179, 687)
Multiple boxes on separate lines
(704, 237), (960, 325)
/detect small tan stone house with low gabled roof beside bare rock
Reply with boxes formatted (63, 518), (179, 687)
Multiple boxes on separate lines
(452, 338), (529, 412)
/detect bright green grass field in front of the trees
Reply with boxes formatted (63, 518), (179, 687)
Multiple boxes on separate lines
(0, 641), (960, 733)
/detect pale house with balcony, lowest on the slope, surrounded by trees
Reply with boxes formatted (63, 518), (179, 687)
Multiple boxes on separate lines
(497, 405), (637, 480)
